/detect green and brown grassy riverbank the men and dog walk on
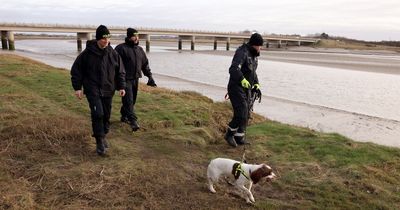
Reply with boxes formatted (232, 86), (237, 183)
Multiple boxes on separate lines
(0, 55), (400, 209)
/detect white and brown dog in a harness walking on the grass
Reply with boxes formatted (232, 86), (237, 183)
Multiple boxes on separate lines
(207, 158), (276, 203)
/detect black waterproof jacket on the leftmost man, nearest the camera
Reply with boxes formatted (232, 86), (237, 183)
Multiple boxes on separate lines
(71, 40), (125, 97)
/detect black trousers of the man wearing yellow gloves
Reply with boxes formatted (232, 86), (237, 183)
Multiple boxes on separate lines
(228, 86), (249, 133)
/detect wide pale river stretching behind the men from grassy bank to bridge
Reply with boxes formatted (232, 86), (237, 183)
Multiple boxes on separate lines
(7, 40), (400, 147)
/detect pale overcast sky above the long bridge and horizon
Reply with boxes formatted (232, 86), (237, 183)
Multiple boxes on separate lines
(0, 0), (400, 41)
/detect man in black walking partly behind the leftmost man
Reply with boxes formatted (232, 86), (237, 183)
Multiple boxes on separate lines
(115, 28), (157, 131)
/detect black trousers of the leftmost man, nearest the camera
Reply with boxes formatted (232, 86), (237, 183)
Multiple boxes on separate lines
(86, 96), (112, 138)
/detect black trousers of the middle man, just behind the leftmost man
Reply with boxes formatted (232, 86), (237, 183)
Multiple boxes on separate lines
(120, 79), (139, 122)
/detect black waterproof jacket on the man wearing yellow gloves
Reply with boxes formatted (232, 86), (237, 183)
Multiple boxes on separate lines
(228, 44), (259, 89)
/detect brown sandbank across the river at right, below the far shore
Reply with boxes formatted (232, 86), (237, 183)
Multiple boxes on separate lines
(201, 47), (400, 74)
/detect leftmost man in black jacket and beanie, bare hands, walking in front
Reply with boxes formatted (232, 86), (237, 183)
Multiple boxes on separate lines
(71, 25), (125, 155)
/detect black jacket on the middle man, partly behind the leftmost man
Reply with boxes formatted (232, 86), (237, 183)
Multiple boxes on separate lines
(115, 38), (152, 79)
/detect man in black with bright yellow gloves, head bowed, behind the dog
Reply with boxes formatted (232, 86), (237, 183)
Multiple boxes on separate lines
(224, 33), (264, 147)
